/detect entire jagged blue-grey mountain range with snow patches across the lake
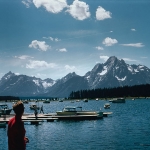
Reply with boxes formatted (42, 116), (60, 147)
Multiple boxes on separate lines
(0, 56), (150, 97)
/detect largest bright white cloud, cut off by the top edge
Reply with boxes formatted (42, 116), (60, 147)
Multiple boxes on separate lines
(33, 0), (67, 13)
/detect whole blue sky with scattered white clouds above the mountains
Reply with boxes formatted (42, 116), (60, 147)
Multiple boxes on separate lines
(0, 0), (150, 80)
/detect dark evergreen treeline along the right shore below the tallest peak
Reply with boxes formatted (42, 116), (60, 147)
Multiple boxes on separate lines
(69, 84), (150, 99)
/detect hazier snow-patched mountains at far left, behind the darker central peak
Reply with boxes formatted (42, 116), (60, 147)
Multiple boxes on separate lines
(0, 71), (55, 96)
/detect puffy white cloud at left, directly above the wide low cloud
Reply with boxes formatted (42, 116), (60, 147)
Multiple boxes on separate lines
(29, 40), (51, 51)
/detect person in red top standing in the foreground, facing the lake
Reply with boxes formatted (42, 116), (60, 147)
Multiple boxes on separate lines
(7, 101), (29, 150)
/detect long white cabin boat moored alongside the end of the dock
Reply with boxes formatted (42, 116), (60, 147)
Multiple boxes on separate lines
(56, 106), (100, 116)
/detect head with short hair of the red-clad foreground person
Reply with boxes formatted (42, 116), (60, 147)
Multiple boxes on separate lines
(13, 101), (24, 115)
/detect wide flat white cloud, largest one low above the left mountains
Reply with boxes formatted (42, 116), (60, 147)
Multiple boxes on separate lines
(26, 60), (57, 69)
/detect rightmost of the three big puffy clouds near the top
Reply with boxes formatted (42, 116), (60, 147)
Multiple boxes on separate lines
(96, 6), (112, 20)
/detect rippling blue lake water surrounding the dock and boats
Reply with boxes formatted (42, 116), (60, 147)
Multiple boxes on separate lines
(0, 99), (150, 150)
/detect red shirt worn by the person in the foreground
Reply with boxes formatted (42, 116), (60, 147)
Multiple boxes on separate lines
(7, 116), (26, 150)
